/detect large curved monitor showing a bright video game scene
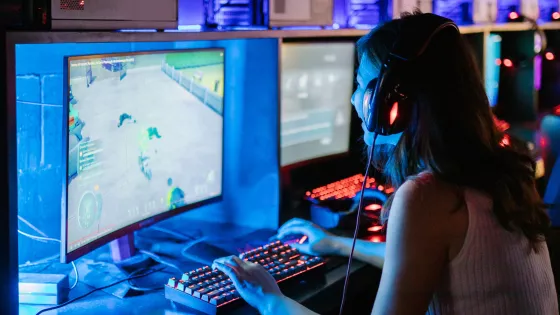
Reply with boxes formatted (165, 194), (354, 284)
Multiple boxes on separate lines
(61, 49), (224, 262)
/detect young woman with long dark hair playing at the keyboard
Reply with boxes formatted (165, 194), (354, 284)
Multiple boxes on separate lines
(214, 13), (558, 315)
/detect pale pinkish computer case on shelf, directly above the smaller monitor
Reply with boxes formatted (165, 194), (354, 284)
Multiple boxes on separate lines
(268, 0), (333, 27)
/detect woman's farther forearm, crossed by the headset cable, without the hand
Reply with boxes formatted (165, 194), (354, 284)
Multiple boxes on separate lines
(331, 237), (385, 268)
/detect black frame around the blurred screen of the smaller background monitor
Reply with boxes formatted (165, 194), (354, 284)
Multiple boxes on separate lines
(278, 37), (360, 172)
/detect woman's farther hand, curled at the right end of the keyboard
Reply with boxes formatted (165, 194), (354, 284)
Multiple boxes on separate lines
(277, 218), (337, 256)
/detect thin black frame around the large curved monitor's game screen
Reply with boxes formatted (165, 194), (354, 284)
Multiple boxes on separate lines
(60, 47), (227, 263)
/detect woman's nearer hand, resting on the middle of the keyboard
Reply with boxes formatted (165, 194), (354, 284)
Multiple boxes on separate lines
(212, 256), (283, 313)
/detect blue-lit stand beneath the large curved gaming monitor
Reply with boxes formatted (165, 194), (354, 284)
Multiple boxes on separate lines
(79, 234), (155, 298)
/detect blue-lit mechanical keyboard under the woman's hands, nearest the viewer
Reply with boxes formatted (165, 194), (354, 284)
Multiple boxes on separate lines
(165, 241), (325, 315)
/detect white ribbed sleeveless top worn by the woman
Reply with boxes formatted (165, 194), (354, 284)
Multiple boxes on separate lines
(428, 190), (559, 315)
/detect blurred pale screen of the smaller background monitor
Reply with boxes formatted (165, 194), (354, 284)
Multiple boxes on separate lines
(280, 42), (356, 166)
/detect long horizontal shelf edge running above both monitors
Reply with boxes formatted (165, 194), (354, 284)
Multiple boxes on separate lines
(8, 22), (560, 44)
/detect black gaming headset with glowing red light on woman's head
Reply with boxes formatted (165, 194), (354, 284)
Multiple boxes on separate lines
(362, 13), (459, 136)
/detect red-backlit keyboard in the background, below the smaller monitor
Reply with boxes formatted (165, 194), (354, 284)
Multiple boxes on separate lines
(305, 174), (394, 201)
